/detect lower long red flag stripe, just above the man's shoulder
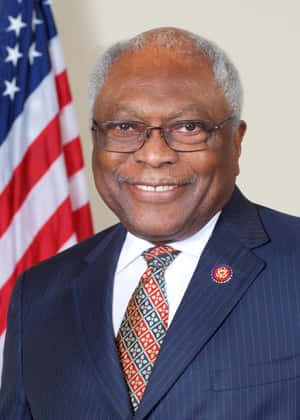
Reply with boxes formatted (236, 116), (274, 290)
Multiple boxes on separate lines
(0, 198), (73, 334)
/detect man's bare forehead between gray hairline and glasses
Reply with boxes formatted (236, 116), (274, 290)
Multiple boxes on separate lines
(95, 45), (227, 119)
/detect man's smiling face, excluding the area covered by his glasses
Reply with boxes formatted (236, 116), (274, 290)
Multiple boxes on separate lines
(93, 47), (245, 244)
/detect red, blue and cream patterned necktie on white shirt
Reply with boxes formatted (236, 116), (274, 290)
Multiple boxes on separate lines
(116, 245), (180, 411)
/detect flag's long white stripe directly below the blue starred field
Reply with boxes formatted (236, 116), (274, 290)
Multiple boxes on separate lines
(0, 73), (58, 192)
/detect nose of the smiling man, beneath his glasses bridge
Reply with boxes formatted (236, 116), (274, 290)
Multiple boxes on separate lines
(134, 127), (178, 168)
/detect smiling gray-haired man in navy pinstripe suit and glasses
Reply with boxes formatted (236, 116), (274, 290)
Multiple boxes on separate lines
(0, 28), (300, 420)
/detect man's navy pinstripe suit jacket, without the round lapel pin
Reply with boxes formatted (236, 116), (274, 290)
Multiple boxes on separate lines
(0, 189), (300, 420)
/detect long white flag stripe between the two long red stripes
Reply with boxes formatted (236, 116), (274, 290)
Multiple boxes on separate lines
(0, 155), (68, 287)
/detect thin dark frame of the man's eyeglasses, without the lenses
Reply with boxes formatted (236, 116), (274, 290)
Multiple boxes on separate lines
(91, 115), (237, 153)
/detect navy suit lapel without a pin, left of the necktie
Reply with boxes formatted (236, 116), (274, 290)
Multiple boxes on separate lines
(74, 226), (132, 419)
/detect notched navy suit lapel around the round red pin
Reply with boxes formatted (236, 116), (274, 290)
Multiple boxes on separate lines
(135, 189), (268, 420)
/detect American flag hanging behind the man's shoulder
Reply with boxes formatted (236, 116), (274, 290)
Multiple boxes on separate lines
(0, 0), (93, 370)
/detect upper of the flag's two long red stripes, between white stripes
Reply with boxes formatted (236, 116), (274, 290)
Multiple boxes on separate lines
(0, 116), (61, 237)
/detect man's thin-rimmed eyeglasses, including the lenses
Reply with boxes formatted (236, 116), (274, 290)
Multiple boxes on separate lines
(92, 116), (236, 153)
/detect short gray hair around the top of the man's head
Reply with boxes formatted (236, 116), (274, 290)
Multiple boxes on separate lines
(89, 28), (243, 124)
